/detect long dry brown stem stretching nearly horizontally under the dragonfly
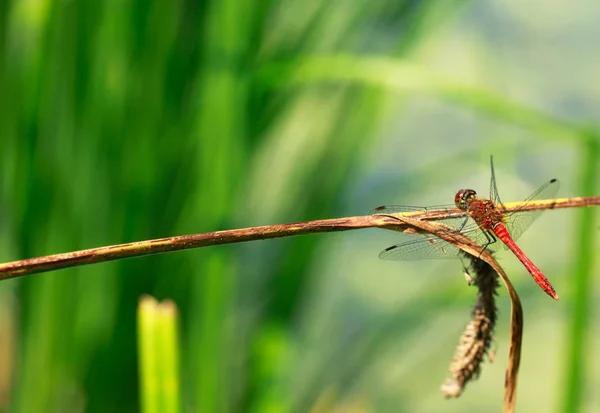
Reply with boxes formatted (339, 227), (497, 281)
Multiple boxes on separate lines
(0, 197), (600, 280)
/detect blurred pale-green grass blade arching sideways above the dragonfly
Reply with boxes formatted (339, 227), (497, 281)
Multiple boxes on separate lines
(261, 56), (598, 143)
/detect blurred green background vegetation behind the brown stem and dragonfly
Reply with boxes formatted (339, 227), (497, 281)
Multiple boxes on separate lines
(0, 0), (600, 412)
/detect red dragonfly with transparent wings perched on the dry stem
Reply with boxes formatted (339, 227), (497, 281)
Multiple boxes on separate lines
(371, 157), (559, 300)
